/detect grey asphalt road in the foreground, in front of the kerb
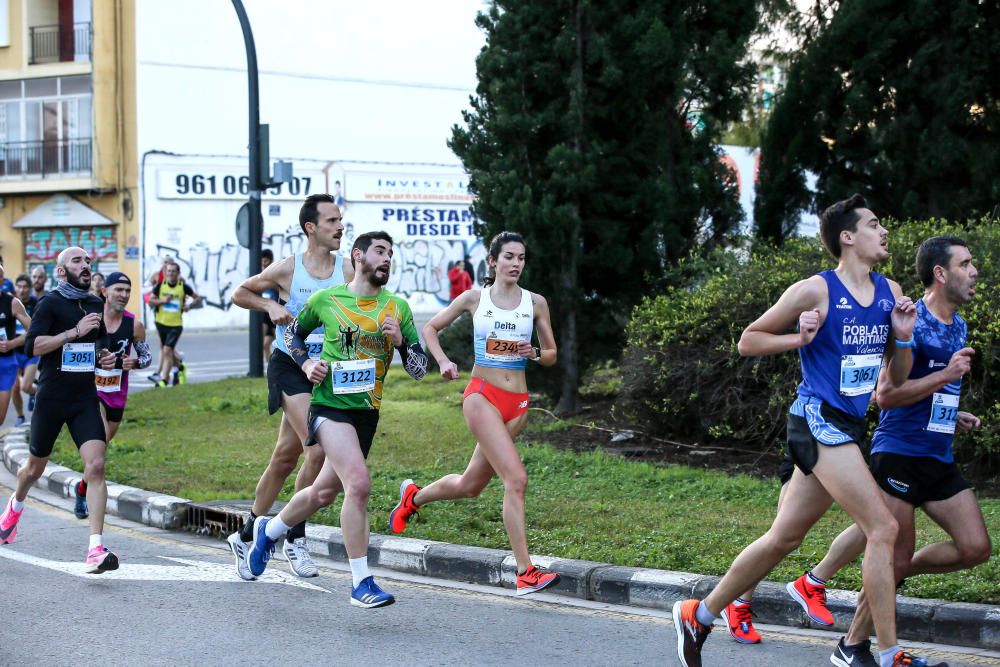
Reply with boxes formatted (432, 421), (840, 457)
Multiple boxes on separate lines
(0, 470), (1000, 667)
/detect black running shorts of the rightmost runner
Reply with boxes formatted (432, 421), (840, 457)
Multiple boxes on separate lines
(869, 452), (969, 507)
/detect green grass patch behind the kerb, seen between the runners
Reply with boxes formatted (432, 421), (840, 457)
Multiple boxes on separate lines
(52, 369), (1000, 604)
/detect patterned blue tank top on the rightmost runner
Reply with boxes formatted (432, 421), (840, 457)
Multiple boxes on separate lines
(872, 299), (967, 463)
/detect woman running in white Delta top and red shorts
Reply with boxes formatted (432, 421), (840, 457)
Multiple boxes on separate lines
(389, 232), (559, 595)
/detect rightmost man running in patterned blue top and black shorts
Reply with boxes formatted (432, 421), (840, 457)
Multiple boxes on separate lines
(816, 236), (992, 667)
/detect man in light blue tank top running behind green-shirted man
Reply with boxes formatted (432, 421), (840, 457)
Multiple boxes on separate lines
(229, 194), (354, 581)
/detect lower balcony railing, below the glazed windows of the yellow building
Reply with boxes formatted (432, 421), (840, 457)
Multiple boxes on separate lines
(0, 139), (91, 180)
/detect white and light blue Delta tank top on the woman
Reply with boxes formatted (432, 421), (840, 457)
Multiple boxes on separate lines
(472, 287), (535, 370)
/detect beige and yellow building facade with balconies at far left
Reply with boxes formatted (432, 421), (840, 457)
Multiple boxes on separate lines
(0, 0), (141, 310)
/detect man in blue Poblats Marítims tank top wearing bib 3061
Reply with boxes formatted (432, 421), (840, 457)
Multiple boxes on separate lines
(673, 195), (944, 667)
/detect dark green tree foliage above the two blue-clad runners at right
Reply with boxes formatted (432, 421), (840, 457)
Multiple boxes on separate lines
(755, 0), (1000, 241)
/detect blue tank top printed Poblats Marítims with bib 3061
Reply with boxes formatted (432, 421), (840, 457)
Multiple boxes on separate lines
(799, 270), (896, 418)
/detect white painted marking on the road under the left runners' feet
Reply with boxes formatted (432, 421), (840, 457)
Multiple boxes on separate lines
(0, 547), (330, 593)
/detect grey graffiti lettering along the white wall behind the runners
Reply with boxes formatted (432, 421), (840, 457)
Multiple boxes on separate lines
(143, 228), (486, 310)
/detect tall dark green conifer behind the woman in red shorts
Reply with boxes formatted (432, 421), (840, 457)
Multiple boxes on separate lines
(450, 0), (757, 412)
